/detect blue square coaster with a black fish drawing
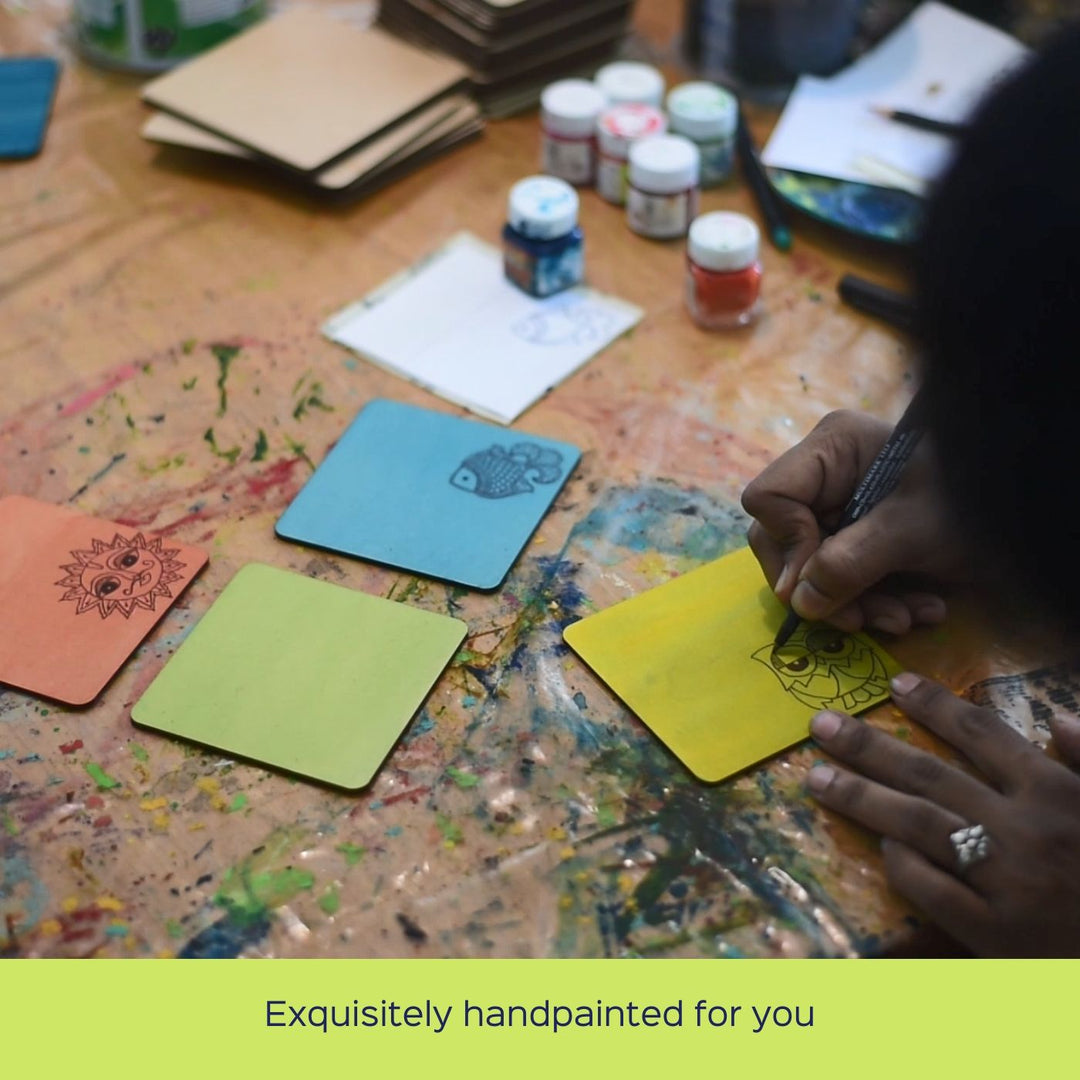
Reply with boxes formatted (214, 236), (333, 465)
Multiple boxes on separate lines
(276, 401), (581, 589)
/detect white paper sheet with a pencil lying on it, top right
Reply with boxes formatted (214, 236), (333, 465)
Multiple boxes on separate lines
(761, 2), (1028, 193)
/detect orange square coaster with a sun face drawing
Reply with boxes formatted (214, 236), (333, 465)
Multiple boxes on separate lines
(0, 495), (207, 705)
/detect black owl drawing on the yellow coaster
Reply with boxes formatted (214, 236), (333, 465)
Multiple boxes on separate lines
(753, 626), (889, 713)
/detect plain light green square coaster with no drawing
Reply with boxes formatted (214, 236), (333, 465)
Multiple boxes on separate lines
(132, 564), (467, 788)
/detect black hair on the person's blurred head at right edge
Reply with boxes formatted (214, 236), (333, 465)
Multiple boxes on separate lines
(916, 21), (1080, 629)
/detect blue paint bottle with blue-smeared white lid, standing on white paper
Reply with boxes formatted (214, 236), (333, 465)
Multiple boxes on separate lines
(502, 176), (585, 298)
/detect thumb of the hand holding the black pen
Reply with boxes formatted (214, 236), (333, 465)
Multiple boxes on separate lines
(792, 503), (910, 620)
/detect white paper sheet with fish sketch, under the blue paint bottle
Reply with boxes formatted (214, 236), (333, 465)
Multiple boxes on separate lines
(323, 233), (643, 423)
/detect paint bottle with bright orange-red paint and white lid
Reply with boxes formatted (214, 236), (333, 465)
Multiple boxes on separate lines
(686, 211), (761, 330)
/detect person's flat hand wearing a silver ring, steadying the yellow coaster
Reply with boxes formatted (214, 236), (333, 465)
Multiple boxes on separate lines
(807, 674), (1080, 957)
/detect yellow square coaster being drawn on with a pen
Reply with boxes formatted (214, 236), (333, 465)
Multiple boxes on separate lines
(563, 548), (901, 781)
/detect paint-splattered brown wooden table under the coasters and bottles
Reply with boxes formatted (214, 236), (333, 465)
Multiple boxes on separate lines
(0, 0), (1067, 956)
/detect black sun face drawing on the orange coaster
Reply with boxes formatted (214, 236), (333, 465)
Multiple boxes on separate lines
(56, 532), (185, 619)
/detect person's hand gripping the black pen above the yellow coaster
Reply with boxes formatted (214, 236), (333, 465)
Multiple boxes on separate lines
(742, 411), (962, 634)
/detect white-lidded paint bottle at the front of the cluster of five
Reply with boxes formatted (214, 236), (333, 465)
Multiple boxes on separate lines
(626, 135), (701, 240)
